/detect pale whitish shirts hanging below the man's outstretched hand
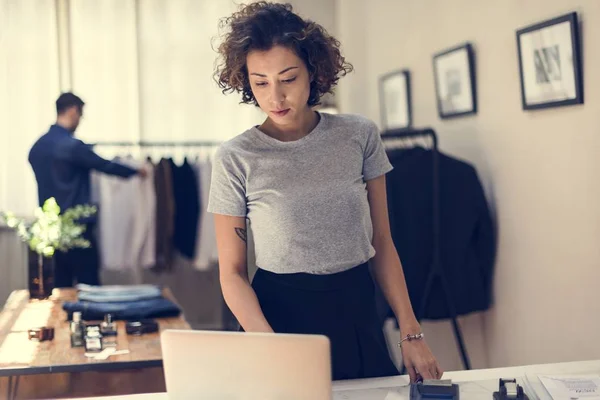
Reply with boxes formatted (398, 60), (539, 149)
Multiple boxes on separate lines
(93, 160), (156, 280)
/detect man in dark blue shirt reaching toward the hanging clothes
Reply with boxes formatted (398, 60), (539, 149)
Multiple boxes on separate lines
(29, 93), (146, 287)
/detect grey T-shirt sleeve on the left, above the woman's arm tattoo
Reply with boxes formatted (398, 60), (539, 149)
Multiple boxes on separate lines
(207, 147), (246, 217)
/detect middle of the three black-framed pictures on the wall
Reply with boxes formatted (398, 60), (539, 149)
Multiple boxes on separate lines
(433, 43), (477, 118)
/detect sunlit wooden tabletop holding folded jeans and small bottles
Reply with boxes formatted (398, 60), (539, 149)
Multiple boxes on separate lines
(0, 289), (190, 376)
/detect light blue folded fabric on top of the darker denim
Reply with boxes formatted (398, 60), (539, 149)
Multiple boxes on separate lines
(76, 284), (162, 303)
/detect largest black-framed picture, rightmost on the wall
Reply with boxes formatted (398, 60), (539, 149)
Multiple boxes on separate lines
(517, 13), (583, 110)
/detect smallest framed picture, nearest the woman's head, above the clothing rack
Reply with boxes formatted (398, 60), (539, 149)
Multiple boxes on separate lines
(379, 70), (412, 131)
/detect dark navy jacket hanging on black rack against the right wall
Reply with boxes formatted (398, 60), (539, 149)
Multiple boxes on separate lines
(387, 147), (495, 319)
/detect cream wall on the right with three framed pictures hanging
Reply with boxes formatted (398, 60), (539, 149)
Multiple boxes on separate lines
(336, 0), (600, 369)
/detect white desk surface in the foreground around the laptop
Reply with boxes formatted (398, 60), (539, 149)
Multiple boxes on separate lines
(74, 360), (600, 400)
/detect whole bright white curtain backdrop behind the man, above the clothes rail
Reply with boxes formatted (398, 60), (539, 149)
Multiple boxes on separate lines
(0, 0), (262, 215)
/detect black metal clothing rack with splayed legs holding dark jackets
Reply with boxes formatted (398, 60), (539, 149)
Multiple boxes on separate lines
(381, 128), (471, 374)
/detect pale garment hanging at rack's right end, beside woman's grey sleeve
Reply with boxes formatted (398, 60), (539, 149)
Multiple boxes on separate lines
(194, 159), (219, 271)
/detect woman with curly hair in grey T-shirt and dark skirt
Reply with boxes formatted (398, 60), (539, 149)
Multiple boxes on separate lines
(208, 2), (442, 381)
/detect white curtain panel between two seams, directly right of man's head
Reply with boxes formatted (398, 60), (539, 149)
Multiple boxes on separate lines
(68, 0), (140, 142)
